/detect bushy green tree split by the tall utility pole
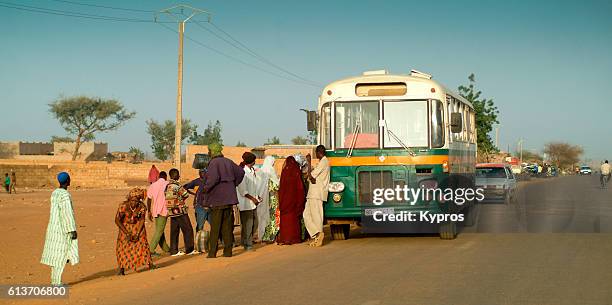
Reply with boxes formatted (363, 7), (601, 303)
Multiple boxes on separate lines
(147, 119), (198, 161)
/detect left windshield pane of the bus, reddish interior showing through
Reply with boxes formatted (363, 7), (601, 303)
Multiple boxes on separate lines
(335, 101), (379, 148)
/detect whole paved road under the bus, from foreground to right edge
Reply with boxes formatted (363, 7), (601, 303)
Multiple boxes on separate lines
(56, 177), (612, 305)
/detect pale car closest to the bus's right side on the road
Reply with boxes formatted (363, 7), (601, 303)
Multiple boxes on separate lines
(476, 163), (516, 204)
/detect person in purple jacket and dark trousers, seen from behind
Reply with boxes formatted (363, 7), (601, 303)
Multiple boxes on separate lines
(204, 143), (244, 258)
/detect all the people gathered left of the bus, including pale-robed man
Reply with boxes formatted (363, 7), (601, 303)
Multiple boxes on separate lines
(41, 144), (330, 285)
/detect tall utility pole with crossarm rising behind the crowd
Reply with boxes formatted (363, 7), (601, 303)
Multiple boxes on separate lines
(155, 4), (210, 171)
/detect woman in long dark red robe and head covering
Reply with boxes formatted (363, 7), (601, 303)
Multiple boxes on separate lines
(277, 157), (306, 245)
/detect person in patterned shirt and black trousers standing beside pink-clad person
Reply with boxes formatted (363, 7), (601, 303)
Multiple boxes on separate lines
(166, 168), (199, 256)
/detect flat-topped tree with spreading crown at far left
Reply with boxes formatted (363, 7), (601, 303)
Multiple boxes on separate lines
(49, 96), (136, 161)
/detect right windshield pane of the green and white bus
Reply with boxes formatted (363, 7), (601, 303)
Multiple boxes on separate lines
(384, 101), (429, 148)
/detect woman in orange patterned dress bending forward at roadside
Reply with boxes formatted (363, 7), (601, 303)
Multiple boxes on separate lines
(115, 188), (155, 275)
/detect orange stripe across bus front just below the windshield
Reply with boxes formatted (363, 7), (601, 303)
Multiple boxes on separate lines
(327, 155), (448, 166)
